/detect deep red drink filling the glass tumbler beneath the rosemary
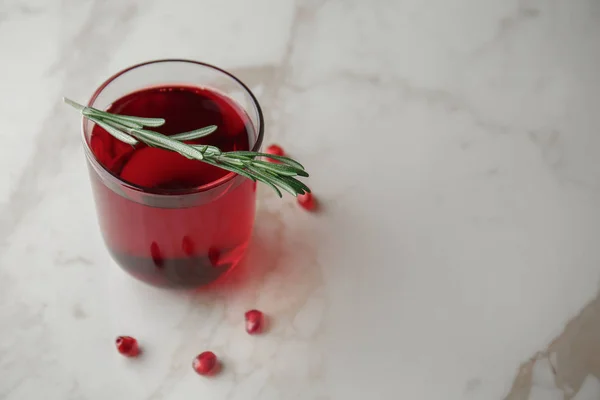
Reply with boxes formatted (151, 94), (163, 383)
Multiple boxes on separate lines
(90, 87), (255, 287)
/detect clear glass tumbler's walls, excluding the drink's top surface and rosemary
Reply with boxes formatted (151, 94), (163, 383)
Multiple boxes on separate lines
(82, 60), (264, 288)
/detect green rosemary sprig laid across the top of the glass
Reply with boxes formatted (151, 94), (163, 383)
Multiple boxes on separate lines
(63, 97), (310, 197)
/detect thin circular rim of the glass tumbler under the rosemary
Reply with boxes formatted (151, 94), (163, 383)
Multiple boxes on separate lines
(81, 58), (265, 197)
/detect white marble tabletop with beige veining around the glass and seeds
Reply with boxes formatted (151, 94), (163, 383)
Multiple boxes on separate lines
(0, 0), (600, 400)
